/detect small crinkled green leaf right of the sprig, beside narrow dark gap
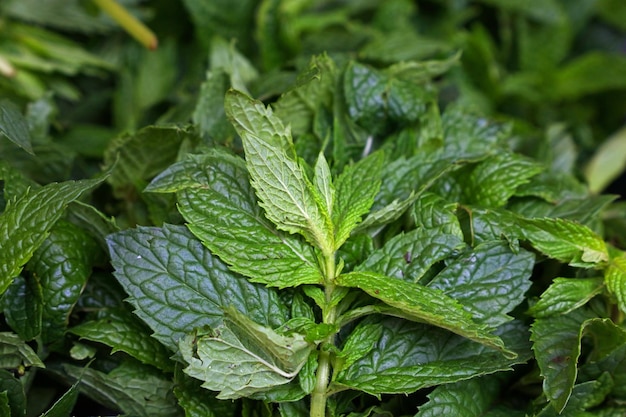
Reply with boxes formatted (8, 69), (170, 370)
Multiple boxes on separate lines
(412, 192), (463, 238)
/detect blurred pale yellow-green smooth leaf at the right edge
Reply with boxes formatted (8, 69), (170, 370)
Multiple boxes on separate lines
(585, 123), (626, 193)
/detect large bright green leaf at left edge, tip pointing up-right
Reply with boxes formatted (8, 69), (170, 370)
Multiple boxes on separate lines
(0, 178), (103, 294)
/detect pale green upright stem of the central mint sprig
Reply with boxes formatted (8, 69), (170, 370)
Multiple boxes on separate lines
(310, 253), (337, 417)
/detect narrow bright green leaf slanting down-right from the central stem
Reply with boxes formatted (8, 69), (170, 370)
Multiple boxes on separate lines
(337, 271), (515, 357)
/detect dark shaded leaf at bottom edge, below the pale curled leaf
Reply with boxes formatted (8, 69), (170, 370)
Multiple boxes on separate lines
(174, 367), (238, 417)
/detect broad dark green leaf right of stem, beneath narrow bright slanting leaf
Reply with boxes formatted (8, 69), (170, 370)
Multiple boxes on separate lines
(331, 317), (531, 395)
